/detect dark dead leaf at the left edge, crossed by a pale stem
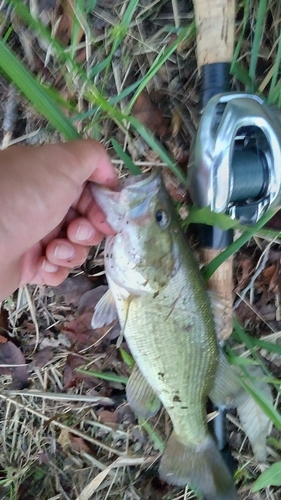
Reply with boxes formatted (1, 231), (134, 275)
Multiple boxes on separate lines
(0, 340), (28, 389)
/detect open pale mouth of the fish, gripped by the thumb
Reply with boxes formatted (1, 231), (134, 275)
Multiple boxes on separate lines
(91, 170), (161, 232)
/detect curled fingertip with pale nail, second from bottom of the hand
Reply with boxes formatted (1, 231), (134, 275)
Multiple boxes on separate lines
(45, 238), (89, 268)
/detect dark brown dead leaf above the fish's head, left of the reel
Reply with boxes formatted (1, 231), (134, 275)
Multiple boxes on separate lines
(132, 90), (169, 137)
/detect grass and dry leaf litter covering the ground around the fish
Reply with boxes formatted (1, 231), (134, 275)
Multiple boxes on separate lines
(0, 0), (281, 500)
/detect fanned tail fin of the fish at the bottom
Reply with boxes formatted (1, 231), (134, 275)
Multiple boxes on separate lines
(159, 431), (235, 500)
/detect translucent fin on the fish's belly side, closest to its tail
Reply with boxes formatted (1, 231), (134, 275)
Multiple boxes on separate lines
(126, 365), (161, 419)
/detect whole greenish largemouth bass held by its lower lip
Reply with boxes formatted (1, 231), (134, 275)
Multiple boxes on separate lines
(93, 172), (237, 500)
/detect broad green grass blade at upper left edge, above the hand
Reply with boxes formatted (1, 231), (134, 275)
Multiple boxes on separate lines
(0, 40), (80, 139)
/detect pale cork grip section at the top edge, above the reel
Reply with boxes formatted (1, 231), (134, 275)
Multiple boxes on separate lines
(193, 0), (235, 70)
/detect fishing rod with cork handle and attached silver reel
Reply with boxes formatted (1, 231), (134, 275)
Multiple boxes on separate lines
(189, 0), (281, 469)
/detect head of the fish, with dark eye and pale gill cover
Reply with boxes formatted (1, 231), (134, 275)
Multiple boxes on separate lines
(92, 171), (179, 294)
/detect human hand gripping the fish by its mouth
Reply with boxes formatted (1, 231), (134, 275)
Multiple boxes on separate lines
(0, 140), (117, 300)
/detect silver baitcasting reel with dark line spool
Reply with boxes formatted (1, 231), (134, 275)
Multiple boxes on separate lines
(189, 92), (281, 224)
